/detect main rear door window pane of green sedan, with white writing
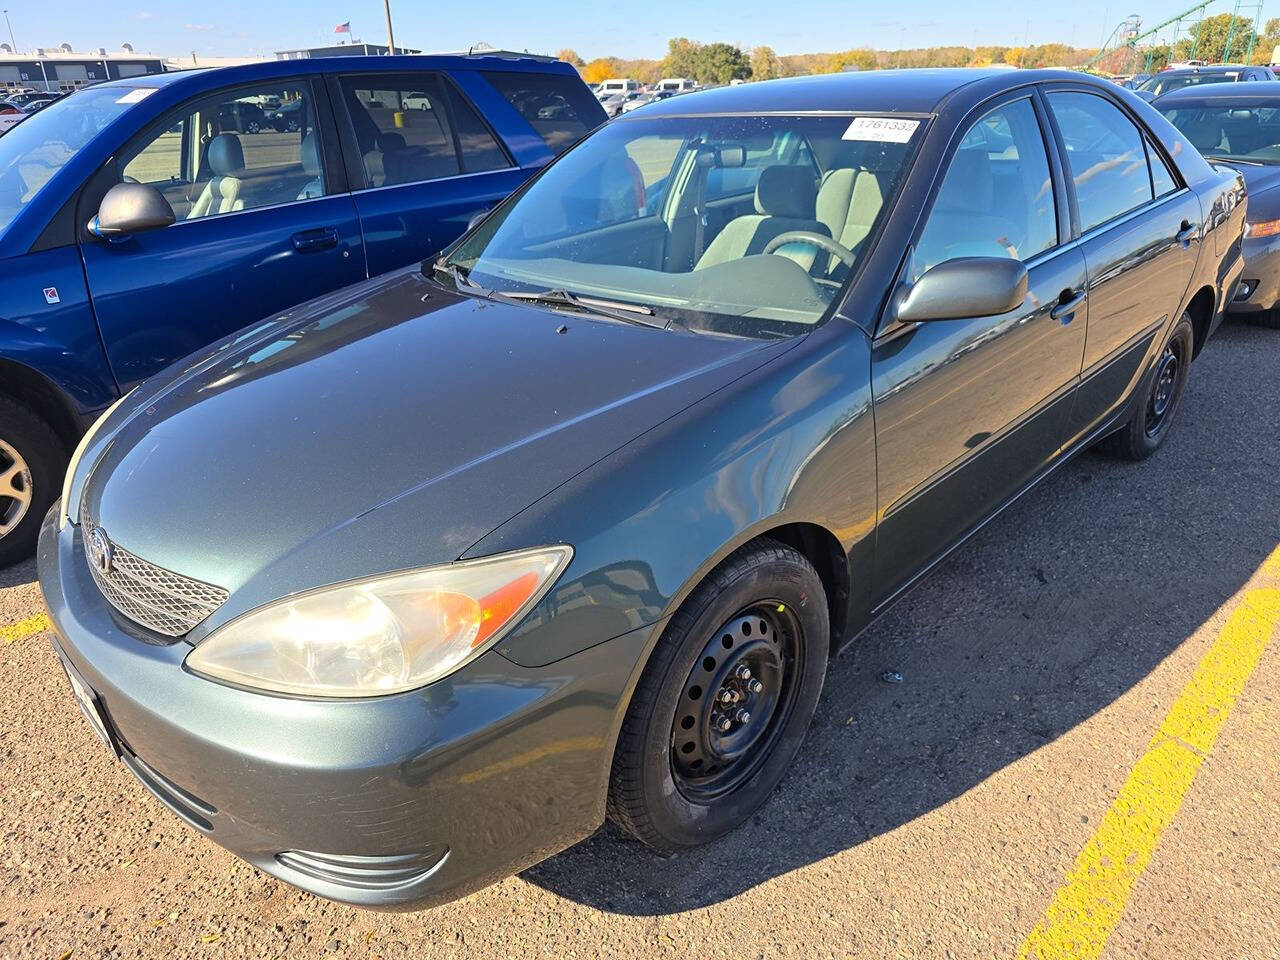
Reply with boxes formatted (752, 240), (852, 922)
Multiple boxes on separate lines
(1048, 92), (1152, 230)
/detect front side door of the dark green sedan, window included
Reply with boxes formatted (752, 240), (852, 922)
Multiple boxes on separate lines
(872, 97), (1085, 602)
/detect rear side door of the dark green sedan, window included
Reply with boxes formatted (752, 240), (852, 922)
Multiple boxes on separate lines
(1046, 88), (1203, 439)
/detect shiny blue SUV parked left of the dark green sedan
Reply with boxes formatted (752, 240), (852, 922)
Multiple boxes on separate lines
(0, 56), (605, 564)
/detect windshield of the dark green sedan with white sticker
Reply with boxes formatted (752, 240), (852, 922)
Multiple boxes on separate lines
(444, 114), (922, 338)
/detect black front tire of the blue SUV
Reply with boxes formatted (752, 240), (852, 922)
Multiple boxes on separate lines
(0, 397), (68, 567)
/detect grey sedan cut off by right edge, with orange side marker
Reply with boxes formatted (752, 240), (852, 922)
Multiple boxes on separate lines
(1155, 81), (1280, 328)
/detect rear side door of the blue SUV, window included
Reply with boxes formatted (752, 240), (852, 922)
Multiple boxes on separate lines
(330, 70), (529, 276)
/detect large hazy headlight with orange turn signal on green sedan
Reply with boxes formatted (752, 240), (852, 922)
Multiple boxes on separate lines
(187, 547), (573, 696)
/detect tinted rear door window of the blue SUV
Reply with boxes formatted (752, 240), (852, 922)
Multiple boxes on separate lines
(340, 73), (511, 187)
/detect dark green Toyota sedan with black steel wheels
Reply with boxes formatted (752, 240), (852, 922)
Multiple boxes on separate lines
(38, 70), (1244, 908)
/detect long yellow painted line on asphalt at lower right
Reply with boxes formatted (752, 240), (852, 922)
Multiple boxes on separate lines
(1018, 549), (1280, 960)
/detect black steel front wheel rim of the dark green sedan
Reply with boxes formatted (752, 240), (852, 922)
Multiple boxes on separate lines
(671, 609), (804, 804)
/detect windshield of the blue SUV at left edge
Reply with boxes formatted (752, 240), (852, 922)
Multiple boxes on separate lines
(0, 87), (151, 234)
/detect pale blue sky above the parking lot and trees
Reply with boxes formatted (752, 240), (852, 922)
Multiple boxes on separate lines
(0, 0), (1141, 59)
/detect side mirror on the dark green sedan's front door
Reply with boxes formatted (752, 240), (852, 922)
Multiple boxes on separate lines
(895, 257), (1027, 324)
